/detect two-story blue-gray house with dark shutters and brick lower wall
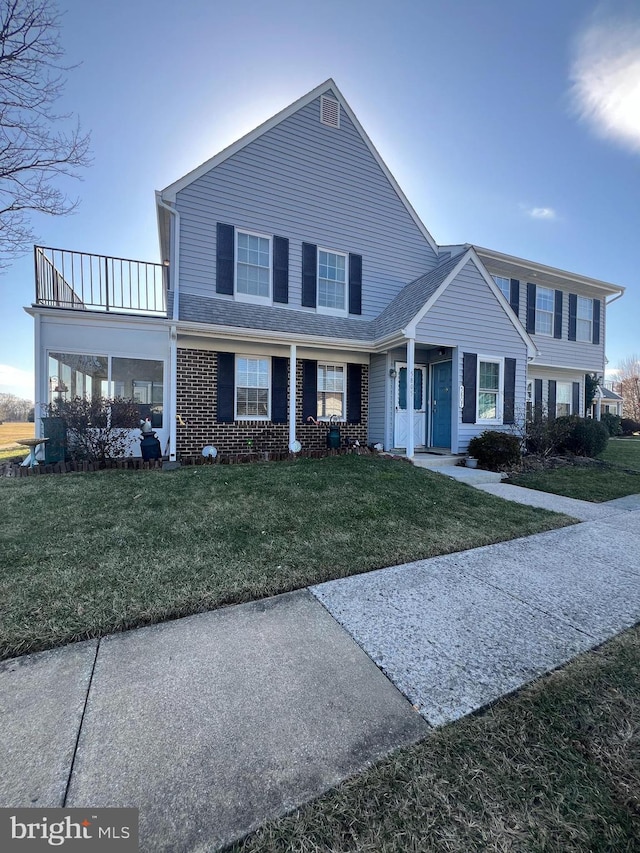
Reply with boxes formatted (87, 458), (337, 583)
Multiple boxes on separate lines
(26, 80), (623, 459)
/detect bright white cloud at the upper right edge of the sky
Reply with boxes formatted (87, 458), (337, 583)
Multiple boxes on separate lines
(570, 13), (640, 152)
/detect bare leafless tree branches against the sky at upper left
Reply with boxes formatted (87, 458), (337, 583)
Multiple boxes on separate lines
(0, 0), (89, 266)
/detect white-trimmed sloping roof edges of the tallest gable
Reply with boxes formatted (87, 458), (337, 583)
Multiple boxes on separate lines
(158, 78), (438, 255)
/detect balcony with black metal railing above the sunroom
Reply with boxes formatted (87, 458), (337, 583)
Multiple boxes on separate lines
(34, 246), (168, 317)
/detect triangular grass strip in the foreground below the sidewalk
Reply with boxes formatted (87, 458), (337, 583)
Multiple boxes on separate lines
(232, 628), (640, 853)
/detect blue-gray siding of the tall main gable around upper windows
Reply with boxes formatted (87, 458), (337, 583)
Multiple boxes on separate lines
(176, 90), (437, 320)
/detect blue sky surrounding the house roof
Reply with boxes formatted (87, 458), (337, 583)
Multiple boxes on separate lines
(0, 0), (640, 397)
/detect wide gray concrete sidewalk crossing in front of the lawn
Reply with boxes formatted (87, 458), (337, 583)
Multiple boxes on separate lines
(0, 484), (640, 851)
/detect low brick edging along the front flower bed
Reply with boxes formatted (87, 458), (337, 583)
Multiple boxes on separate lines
(0, 447), (377, 478)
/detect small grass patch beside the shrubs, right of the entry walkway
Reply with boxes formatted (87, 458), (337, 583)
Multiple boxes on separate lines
(508, 438), (640, 503)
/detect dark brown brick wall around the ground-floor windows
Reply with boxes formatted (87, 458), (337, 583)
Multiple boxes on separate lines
(177, 348), (369, 456)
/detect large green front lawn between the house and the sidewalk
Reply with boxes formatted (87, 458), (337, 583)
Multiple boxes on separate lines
(0, 456), (570, 657)
